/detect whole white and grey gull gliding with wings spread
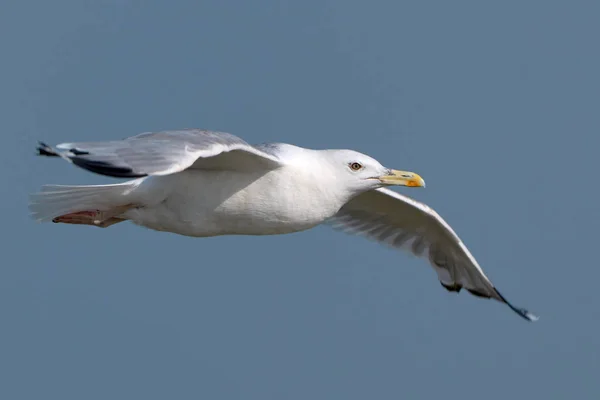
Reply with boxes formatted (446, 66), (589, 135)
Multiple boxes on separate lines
(29, 129), (538, 321)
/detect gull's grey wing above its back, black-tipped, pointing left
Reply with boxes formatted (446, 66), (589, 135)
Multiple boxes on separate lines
(38, 129), (281, 178)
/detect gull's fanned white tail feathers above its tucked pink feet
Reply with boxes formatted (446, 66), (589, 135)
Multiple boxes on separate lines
(29, 180), (138, 222)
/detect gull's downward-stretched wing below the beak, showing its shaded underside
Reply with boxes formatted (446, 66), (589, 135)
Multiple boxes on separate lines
(329, 188), (537, 321)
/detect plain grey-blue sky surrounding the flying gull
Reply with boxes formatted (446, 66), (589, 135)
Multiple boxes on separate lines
(0, 0), (600, 400)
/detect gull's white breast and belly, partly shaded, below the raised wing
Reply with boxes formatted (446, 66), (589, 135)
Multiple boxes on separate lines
(127, 166), (347, 236)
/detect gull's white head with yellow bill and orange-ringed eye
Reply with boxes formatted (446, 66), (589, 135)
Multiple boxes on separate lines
(330, 150), (425, 194)
